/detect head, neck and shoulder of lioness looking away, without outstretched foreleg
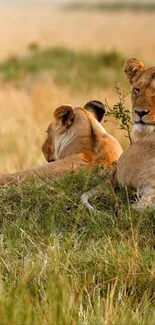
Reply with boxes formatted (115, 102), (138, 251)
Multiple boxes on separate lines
(42, 100), (122, 166)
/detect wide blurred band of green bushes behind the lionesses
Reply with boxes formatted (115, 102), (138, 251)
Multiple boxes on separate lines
(0, 44), (125, 91)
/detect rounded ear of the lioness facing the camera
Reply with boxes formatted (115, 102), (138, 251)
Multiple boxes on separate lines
(124, 58), (145, 85)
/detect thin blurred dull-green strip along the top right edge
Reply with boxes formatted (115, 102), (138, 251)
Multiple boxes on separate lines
(64, 1), (155, 12)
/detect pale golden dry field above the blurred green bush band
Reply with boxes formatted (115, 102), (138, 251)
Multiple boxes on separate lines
(0, 9), (155, 62)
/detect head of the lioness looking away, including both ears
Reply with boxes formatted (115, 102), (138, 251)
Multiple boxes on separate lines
(42, 101), (105, 162)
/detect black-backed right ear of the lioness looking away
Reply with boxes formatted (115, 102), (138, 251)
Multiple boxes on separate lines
(84, 100), (105, 122)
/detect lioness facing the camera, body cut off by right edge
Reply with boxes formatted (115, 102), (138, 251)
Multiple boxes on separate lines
(115, 59), (155, 209)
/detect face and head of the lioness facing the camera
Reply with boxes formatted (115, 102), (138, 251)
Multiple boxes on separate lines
(124, 58), (155, 141)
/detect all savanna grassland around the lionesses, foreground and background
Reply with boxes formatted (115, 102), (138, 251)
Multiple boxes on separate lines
(0, 8), (155, 325)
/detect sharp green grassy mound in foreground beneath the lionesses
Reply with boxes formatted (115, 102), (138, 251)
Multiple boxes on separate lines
(0, 169), (155, 325)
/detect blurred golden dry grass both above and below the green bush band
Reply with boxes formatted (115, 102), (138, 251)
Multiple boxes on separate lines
(0, 9), (155, 172)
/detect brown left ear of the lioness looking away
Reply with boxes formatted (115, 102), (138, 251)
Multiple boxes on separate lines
(54, 105), (75, 128)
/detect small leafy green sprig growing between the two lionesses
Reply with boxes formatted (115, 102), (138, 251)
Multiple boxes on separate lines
(105, 84), (132, 144)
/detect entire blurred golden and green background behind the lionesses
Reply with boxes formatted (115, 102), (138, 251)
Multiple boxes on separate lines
(0, 0), (155, 172)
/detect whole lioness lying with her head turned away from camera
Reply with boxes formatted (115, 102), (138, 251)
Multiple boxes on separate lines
(0, 101), (122, 185)
